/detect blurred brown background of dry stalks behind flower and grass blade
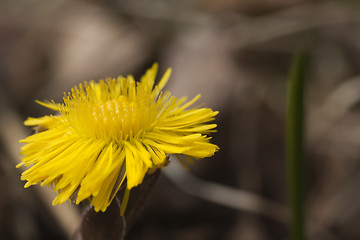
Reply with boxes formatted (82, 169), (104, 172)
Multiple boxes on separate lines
(0, 0), (360, 240)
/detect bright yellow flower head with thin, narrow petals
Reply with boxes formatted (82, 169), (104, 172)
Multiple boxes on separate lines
(17, 64), (218, 211)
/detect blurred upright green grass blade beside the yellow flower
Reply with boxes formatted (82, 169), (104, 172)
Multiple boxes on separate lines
(286, 52), (306, 240)
